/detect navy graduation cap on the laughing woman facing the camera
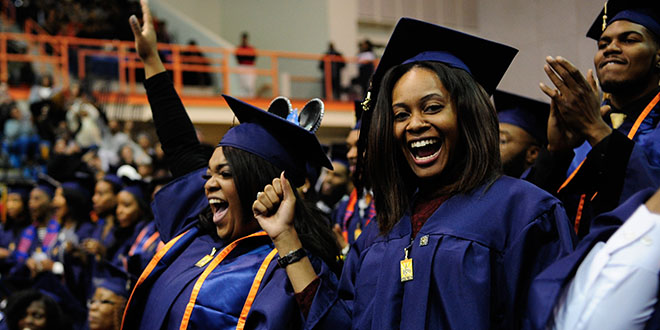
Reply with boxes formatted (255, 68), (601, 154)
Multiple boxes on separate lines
(371, 17), (518, 109)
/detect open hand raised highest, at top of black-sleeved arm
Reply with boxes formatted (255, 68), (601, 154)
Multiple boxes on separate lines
(128, 0), (165, 78)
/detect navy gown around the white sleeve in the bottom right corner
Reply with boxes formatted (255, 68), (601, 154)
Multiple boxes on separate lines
(524, 189), (660, 329)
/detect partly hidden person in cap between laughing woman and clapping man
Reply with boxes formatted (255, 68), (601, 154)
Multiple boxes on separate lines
(493, 91), (550, 178)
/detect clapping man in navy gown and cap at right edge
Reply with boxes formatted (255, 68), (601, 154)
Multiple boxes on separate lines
(528, 0), (660, 237)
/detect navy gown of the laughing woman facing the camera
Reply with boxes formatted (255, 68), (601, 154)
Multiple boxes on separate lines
(312, 177), (573, 329)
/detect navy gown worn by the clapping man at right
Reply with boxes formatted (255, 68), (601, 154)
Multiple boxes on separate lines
(529, 88), (660, 237)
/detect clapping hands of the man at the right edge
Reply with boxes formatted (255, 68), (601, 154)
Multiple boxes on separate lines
(540, 56), (612, 145)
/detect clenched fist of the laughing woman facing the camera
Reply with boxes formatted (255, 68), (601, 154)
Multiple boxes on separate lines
(252, 172), (298, 245)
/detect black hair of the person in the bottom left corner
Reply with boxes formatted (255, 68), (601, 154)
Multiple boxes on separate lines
(5, 289), (64, 330)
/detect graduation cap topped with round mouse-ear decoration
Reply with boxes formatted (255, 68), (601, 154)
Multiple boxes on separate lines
(218, 95), (332, 186)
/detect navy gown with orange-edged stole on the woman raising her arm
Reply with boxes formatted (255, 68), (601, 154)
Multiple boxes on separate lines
(124, 168), (337, 329)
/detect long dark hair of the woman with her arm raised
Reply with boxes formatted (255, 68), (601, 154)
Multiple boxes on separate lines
(202, 146), (339, 271)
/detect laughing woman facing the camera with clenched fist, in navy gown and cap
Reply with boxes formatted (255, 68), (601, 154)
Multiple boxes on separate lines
(253, 18), (573, 329)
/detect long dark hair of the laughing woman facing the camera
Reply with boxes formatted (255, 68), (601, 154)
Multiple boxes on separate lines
(366, 62), (501, 234)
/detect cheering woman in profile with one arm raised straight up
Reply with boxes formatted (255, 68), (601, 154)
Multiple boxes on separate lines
(123, 0), (338, 329)
